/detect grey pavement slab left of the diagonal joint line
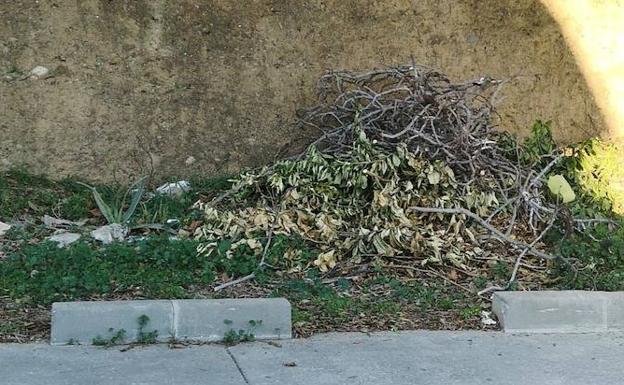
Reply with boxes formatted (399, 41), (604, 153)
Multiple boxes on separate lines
(0, 345), (245, 385)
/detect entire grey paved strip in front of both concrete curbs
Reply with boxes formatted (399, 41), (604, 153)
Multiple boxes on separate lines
(0, 331), (624, 385)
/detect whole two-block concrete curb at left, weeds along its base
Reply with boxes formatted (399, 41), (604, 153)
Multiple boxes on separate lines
(50, 298), (292, 345)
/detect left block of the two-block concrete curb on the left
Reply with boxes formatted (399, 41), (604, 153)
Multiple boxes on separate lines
(50, 300), (173, 345)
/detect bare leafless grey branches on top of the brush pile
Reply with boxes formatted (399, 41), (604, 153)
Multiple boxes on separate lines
(301, 66), (558, 233)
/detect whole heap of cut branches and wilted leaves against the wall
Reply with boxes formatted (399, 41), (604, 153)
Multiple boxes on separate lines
(196, 66), (580, 294)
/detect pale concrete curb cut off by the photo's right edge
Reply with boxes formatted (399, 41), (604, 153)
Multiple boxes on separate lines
(492, 290), (624, 333)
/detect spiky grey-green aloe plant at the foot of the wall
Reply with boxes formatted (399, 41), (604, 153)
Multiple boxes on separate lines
(78, 177), (147, 225)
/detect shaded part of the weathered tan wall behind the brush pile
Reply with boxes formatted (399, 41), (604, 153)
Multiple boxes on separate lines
(0, 0), (604, 180)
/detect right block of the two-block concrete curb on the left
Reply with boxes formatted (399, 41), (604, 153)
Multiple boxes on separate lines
(172, 298), (292, 342)
